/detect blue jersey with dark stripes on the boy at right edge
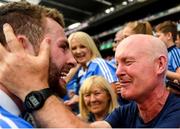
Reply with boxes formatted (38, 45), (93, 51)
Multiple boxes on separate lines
(168, 45), (180, 72)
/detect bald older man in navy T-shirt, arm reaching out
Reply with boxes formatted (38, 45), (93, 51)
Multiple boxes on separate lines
(0, 26), (180, 128)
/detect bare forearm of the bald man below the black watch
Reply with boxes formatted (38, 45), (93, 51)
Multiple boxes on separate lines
(33, 96), (90, 128)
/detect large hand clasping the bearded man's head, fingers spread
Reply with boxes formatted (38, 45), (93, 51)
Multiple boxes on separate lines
(0, 24), (50, 100)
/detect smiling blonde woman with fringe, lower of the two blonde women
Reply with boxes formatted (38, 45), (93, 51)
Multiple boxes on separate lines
(79, 76), (118, 122)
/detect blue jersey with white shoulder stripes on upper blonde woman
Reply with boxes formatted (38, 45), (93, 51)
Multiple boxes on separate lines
(66, 58), (118, 94)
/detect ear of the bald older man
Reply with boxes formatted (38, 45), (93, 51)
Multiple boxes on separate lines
(157, 55), (167, 74)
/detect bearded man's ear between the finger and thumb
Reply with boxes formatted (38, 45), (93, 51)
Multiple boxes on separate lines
(17, 35), (35, 55)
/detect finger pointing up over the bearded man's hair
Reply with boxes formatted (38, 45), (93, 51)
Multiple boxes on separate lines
(3, 23), (24, 52)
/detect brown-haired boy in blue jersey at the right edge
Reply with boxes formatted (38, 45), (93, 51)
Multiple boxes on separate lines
(155, 21), (180, 82)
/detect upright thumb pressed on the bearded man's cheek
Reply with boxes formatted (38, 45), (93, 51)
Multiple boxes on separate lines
(38, 38), (51, 64)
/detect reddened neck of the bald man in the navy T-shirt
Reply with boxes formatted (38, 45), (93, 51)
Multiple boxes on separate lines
(138, 88), (169, 123)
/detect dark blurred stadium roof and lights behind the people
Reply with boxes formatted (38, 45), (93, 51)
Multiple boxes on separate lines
(0, 0), (180, 57)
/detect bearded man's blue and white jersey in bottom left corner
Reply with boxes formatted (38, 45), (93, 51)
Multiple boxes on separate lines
(0, 106), (32, 129)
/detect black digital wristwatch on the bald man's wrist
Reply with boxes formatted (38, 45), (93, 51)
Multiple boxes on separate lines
(24, 88), (54, 113)
